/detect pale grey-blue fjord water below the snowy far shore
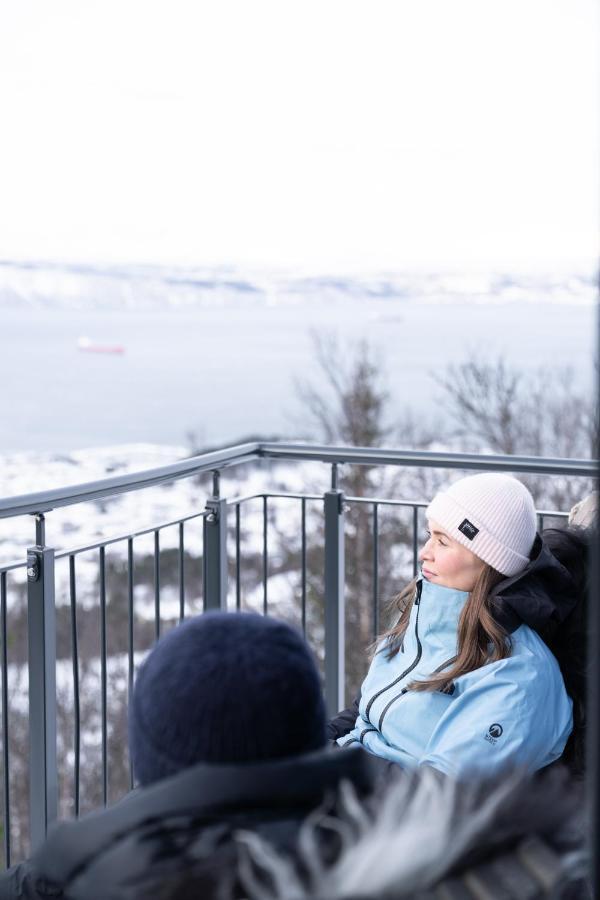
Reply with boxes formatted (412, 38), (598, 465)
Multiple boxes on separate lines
(0, 297), (596, 452)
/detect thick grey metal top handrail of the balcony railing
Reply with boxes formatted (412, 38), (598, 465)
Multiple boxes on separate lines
(0, 441), (598, 519)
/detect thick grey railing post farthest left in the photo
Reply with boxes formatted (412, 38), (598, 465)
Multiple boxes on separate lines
(27, 514), (58, 850)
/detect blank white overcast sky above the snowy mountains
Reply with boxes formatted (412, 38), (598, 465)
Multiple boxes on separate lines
(0, 0), (600, 270)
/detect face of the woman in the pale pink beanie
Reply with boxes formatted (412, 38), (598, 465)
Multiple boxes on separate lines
(419, 519), (485, 591)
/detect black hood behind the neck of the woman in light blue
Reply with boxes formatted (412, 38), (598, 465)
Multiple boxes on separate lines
(491, 532), (581, 634)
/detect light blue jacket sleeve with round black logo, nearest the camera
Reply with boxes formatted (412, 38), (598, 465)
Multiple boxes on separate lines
(419, 657), (573, 777)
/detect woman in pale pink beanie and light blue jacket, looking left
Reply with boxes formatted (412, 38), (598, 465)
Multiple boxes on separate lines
(329, 474), (578, 777)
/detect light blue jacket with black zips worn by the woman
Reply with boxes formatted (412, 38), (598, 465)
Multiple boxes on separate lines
(338, 578), (573, 776)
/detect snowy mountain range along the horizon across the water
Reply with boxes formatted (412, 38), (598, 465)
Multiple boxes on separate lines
(0, 260), (596, 309)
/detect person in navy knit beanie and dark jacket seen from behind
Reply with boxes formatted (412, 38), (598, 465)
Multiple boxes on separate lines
(0, 613), (373, 900)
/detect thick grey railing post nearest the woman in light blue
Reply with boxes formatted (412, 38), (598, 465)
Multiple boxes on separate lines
(323, 463), (345, 716)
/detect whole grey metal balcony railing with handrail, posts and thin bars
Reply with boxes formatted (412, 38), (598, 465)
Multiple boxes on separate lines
(0, 442), (597, 865)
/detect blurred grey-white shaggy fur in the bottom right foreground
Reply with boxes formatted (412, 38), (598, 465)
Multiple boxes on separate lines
(238, 767), (591, 900)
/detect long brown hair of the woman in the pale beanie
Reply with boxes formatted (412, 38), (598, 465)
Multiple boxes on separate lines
(379, 563), (511, 691)
